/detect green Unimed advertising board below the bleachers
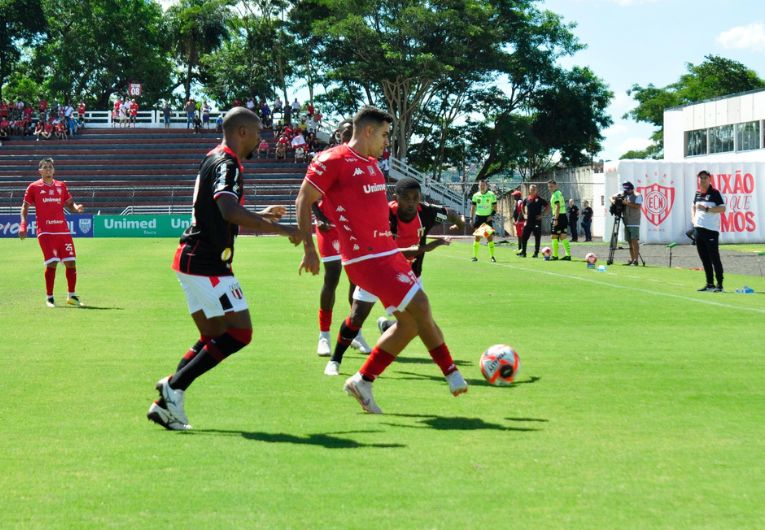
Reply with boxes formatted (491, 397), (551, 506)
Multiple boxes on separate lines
(93, 215), (191, 237)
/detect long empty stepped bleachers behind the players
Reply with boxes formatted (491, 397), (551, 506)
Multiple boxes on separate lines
(0, 128), (306, 214)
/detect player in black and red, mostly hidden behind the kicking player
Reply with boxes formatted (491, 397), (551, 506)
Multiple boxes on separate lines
(324, 177), (465, 375)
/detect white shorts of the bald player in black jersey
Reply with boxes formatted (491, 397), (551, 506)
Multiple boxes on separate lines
(175, 271), (248, 318)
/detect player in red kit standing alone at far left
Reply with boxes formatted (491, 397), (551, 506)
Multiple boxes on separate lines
(19, 158), (85, 307)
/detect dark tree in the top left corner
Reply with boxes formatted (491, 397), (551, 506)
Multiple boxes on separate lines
(0, 0), (47, 99)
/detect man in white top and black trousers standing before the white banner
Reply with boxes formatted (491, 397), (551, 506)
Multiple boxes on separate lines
(691, 171), (725, 293)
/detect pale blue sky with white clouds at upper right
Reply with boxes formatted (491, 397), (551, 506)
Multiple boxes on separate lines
(539, 0), (765, 160)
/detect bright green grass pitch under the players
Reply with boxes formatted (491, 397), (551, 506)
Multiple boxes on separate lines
(0, 238), (765, 528)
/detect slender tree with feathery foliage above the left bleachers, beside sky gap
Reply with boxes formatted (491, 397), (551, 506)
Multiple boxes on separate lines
(165, 0), (230, 100)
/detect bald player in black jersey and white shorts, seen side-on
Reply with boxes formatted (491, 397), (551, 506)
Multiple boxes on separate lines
(147, 107), (302, 430)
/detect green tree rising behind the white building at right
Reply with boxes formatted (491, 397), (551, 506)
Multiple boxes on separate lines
(622, 55), (765, 158)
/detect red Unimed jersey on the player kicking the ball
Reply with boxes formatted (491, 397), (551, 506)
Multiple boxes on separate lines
(305, 144), (399, 264)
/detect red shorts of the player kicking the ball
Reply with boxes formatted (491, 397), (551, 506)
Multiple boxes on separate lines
(345, 252), (422, 313)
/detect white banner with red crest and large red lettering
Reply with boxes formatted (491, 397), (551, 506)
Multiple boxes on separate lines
(605, 160), (765, 243)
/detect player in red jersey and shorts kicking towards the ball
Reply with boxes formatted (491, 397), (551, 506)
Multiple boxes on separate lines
(296, 107), (468, 414)
